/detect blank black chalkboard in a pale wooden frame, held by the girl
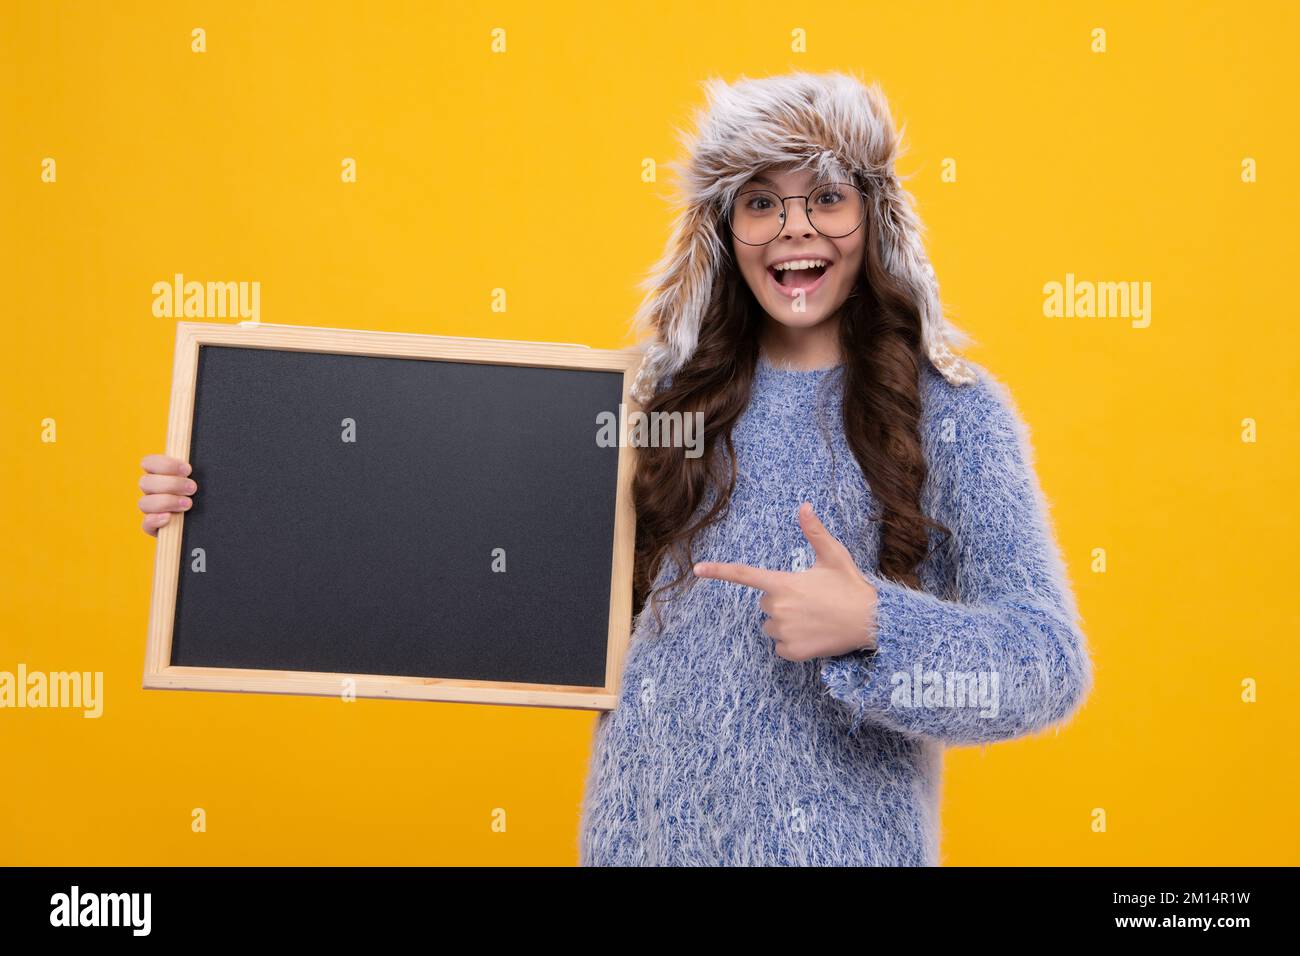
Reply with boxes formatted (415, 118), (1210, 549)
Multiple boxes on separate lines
(146, 323), (637, 709)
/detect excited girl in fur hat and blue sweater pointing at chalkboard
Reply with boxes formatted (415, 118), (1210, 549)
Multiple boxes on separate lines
(140, 73), (1092, 865)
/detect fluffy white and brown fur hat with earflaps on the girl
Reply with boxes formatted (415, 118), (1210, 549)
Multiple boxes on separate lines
(632, 72), (975, 402)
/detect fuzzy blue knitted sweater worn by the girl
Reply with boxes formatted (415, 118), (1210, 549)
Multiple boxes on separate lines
(579, 359), (1092, 866)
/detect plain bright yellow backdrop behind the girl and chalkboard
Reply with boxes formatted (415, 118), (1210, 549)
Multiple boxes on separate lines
(0, 0), (1300, 865)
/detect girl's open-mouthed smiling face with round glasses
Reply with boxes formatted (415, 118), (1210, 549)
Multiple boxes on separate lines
(732, 169), (867, 338)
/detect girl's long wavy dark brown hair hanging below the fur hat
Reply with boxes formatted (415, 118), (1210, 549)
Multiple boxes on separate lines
(632, 195), (952, 629)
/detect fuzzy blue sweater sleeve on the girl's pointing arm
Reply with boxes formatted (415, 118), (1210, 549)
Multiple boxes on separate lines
(820, 368), (1092, 745)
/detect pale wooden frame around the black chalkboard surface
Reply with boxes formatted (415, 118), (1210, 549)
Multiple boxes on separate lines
(144, 323), (641, 710)
